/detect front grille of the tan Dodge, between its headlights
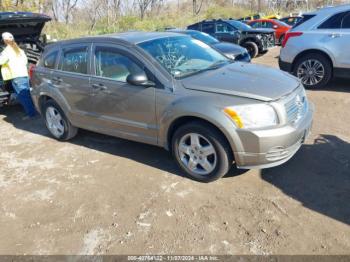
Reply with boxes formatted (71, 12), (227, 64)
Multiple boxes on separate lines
(284, 88), (307, 123)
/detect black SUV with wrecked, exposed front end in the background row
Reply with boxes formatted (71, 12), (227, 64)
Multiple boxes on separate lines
(187, 19), (275, 58)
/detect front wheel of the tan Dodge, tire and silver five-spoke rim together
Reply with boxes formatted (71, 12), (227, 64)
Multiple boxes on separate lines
(172, 121), (233, 183)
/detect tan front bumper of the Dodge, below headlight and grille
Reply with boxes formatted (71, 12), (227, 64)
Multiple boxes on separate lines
(235, 103), (314, 169)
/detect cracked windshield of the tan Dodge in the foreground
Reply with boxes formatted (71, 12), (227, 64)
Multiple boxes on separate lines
(138, 36), (231, 78)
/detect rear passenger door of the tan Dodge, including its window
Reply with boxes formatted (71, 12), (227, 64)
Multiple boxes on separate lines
(51, 44), (91, 127)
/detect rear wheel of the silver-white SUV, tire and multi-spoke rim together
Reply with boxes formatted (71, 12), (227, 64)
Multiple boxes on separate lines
(293, 53), (333, 89)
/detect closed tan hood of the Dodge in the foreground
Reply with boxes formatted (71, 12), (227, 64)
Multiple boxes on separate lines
(181, 62), (300, 101)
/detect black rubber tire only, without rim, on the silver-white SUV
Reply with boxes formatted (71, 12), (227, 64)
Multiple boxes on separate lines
(293, 53), (333, 89)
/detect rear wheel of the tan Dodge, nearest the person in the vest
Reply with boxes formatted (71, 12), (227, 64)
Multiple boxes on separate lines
(42, 100), (78, 141)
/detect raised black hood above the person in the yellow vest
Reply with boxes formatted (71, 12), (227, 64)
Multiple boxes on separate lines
(0, 12), (51, 42)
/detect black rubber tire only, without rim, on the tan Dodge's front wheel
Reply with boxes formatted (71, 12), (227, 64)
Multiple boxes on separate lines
(171, 121), (234, 183)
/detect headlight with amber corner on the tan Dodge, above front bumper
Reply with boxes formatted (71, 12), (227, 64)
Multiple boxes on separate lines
(224, 104), (277, 128)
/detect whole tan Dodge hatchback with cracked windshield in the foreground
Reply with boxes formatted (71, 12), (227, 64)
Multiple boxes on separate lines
(32, 32), (313, 182)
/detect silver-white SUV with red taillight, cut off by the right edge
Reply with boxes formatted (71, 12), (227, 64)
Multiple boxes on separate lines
(280, 5), (350, 88)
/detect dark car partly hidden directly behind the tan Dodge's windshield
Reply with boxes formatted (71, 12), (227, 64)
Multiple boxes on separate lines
(168, 29), (251, 62)
